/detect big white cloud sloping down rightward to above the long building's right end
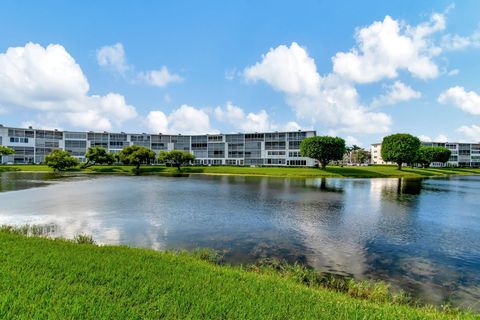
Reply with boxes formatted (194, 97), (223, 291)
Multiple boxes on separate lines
(244, 43), (391, 133)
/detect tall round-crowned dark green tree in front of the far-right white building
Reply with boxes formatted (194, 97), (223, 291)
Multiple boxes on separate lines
(381, 133), (421, 170)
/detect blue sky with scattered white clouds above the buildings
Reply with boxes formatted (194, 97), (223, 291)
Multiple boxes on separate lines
(0, 1), (480, 146)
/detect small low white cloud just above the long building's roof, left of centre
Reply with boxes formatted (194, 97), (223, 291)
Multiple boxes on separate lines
(145, 104), (218, 134)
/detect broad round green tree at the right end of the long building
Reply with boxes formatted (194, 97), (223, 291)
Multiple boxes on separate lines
(300, 136), (346, 169)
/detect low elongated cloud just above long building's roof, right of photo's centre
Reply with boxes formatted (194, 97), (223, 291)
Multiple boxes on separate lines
(213, 102), (300, 132)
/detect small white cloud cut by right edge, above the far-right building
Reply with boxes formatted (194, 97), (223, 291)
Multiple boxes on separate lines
(438, 86), (480, 115)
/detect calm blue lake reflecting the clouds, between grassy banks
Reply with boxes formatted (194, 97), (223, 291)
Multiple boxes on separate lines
(0, 173), (480, 310)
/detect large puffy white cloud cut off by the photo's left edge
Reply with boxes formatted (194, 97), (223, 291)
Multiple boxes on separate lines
(0, 43), (137, 130)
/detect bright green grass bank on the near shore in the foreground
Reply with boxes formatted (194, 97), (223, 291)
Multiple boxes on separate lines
(0, 230), (477, 319)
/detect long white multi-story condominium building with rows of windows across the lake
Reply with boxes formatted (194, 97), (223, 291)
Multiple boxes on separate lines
(0, 125), (316, 166)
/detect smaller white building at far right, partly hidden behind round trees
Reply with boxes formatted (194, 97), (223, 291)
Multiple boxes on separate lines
(371, 142), (480, 167)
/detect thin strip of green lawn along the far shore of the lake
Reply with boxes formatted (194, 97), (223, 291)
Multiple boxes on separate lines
(0, 165), (480, 178)
